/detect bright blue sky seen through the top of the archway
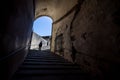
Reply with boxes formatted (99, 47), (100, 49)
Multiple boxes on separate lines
(33, 16), (52, 36)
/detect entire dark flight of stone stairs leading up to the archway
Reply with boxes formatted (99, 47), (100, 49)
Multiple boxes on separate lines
(12, 50), (91, 80)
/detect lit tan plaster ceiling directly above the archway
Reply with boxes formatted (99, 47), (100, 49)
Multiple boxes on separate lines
(35, 0), (77, 22)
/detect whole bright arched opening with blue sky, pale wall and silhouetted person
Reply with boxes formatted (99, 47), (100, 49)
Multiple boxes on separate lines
(30, 16), (53, 50)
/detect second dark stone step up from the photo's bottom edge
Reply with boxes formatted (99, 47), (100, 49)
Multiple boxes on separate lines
(16, 69), (83, 76)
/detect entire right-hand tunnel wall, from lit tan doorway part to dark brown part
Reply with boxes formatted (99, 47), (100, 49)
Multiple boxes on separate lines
(51, 0), (120, 76)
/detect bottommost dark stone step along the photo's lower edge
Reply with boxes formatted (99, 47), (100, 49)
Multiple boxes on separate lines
(13, 74), (88, 80)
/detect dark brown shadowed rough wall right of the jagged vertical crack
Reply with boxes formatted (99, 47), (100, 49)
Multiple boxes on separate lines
(71, 0), (120, 78)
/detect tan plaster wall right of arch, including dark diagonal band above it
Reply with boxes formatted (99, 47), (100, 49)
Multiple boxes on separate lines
(51, 0), (83, 62)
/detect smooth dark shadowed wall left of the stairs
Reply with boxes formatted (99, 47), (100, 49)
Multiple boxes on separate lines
(0, 0), (34, 80)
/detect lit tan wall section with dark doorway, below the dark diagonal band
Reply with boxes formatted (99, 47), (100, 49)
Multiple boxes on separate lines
(52, 11), (75, 61)
